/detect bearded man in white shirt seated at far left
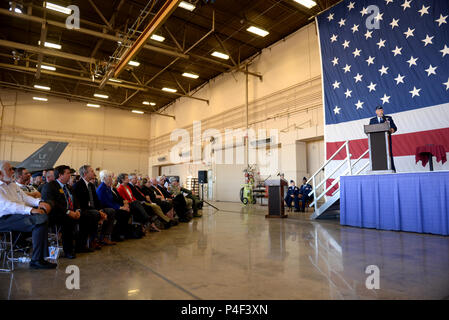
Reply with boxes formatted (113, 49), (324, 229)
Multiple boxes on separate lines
(0, 162), (56, 269)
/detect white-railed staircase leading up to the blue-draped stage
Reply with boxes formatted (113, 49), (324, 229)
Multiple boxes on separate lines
(307, 141), (369, 220)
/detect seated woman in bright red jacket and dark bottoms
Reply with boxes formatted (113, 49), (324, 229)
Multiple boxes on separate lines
(117, 173), (161, 232)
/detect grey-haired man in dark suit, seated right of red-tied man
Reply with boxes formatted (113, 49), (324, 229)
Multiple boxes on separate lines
(73, 165), (115, 250)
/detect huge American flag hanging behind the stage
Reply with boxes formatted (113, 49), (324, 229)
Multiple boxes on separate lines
(317, 0), (449, 175)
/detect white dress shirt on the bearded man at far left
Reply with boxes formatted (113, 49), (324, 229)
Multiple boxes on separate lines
(0, 181), (41, 217)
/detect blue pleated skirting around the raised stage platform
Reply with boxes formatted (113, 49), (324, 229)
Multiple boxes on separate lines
(340, 171), (449, 236)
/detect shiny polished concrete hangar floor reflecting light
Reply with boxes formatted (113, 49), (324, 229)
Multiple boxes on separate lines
(0, 202), (449, 299)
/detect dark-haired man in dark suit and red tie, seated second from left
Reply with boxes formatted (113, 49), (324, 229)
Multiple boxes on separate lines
(42, 165), (81, 259)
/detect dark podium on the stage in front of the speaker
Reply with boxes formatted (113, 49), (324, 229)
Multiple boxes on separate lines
(365, 121), (396, 174)
